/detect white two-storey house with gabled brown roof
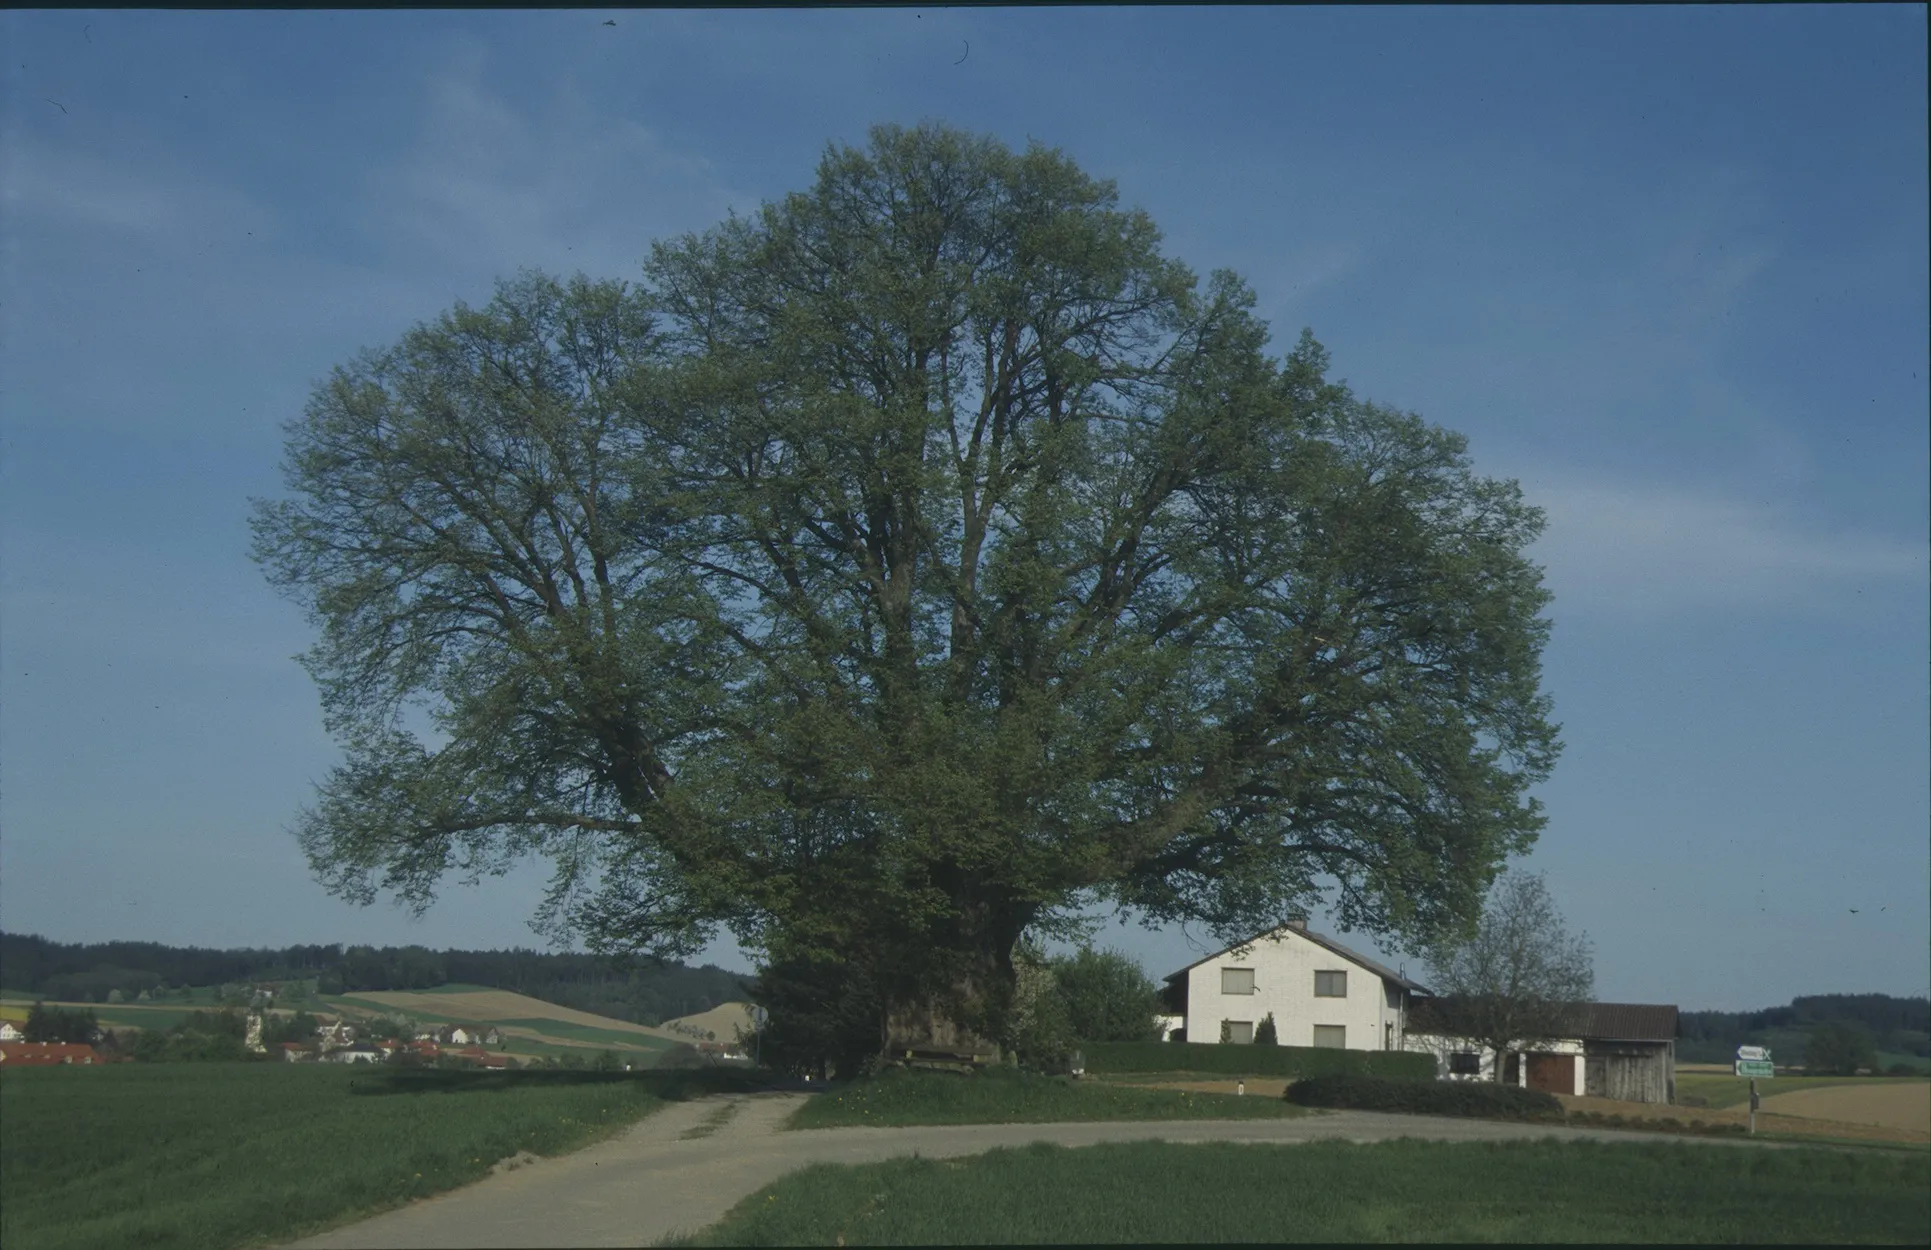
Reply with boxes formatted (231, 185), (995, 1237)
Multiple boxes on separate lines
(1161, 920), (1429, 1051)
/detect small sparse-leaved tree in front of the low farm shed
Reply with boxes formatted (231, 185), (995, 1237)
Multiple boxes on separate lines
(1410, 871), (1595, 1080)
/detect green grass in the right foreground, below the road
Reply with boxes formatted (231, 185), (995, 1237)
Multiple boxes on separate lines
(668, 1142), (1931, 1246)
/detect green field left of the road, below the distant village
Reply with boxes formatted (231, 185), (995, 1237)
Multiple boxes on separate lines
(0, 1063), (768, 1250)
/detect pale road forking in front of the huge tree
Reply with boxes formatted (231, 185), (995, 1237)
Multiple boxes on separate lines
(288, 1094), (1807, 1250)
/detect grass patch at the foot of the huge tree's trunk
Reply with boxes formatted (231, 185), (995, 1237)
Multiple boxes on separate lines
(786, 1068), (1307, 1128)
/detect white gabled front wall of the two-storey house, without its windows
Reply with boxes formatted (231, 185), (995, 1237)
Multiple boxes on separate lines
(1188, 929), (1402, 1051)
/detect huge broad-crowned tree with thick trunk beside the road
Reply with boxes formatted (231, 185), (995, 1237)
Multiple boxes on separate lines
(255, 126), (1556, 1043)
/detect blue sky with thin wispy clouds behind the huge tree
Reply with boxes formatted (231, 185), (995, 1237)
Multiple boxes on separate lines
(0, 6), (1931, 1007)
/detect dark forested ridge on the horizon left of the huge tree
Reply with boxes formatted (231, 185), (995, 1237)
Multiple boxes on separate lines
(0, 933), (751, 1024)
